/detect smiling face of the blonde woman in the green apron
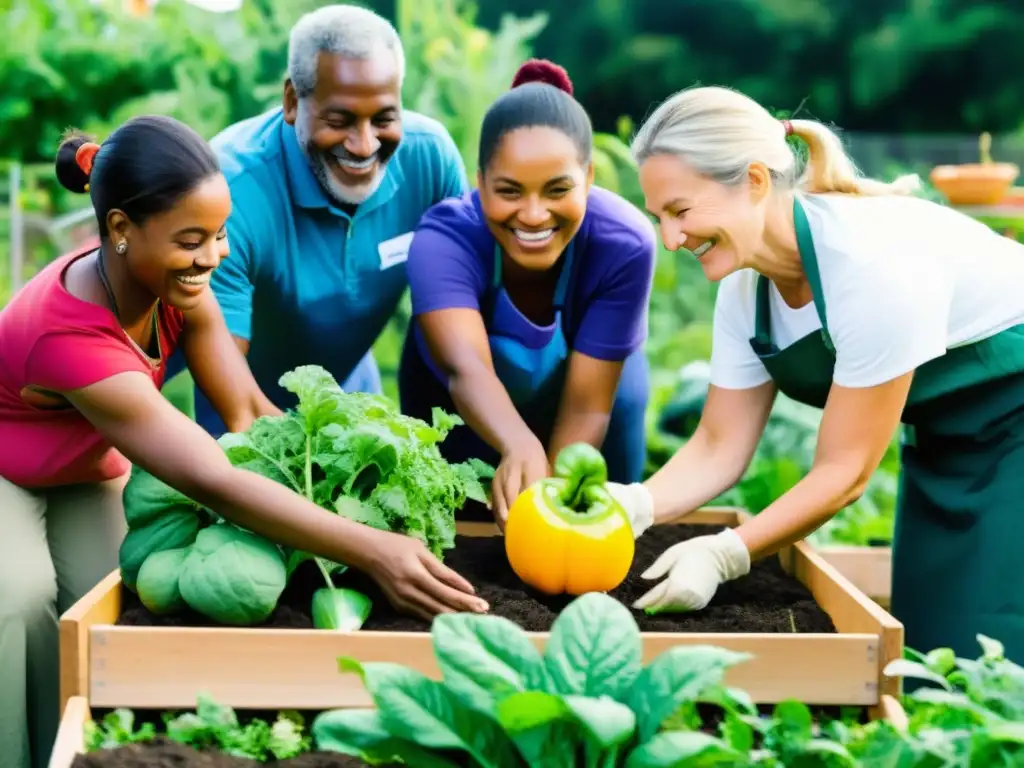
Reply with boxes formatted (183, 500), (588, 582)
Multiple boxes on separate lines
(640, 155), (767, 282)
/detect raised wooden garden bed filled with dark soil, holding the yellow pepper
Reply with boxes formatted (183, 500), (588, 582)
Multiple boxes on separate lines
(60, 509), (903, 710)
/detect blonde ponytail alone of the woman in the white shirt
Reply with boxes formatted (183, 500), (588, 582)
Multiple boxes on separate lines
(786, 120), (921, 196)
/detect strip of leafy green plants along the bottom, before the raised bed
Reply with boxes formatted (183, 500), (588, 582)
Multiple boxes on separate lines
(85, 618), (1024, 768)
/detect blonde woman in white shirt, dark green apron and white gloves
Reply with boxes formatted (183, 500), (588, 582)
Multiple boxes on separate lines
(615, 82), (1024, 658)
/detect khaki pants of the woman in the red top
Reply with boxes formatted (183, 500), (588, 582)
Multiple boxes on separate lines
(0, 475), (128, 768)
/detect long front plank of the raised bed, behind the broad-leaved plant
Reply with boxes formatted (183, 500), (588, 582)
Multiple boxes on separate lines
(89, 627), (879, 709)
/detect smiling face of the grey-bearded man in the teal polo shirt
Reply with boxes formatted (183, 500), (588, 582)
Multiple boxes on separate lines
(285, 48), (401, 205)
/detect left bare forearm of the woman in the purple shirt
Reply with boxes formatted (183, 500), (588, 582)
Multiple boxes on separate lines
(449, 368), (537, 456)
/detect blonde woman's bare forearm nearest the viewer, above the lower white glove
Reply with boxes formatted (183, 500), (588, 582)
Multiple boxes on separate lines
(736, 465), (863, 559)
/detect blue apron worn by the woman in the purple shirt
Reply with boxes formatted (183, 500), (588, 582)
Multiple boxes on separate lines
(398, 241), (649, 493)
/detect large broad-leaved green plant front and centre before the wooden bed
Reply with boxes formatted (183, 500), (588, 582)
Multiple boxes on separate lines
(312, 593), (749, 768)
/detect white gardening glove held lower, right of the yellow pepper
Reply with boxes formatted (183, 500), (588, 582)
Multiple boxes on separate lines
(633, 528), (751, 613)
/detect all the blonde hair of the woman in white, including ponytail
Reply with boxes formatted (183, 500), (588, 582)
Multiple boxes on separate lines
(631, 86), (921, 196)
